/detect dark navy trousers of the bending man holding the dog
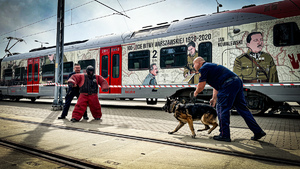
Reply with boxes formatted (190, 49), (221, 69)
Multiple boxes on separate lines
(217, 78), (262, 138)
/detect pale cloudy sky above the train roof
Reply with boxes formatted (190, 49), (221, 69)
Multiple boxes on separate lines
(0, 0), (279, 58)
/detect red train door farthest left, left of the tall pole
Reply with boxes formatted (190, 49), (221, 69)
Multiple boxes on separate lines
(27, 58), (40, 93)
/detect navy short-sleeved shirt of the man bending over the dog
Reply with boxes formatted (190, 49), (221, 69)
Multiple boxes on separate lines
(199, 62), (237, 90)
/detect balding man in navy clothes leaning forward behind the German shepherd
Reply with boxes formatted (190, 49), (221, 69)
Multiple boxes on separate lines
(193, 57), (266, 142)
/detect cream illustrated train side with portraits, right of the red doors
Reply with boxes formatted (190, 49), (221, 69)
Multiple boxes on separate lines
(122, 17), (300, 85)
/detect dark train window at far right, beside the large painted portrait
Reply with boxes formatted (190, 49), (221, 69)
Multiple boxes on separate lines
(273, 22), (300, 46)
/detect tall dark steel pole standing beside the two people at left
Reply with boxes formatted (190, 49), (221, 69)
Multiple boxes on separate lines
(52, 0), (65, 111)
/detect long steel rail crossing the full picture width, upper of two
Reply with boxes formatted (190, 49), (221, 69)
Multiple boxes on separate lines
(0, 117), (300, 166)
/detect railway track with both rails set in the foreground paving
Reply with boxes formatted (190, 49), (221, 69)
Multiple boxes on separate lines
(0, 117), (300, 168)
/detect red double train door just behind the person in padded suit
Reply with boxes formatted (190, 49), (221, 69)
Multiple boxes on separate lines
(100, 46), (122, 94)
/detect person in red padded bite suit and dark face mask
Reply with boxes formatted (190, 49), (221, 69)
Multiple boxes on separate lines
(68, 66), (109, 122)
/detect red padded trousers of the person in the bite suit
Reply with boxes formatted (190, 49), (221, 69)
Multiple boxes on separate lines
(72, 94), (102, 120)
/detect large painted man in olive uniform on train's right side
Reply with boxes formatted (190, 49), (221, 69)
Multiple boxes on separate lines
(233, 32), (279, 83)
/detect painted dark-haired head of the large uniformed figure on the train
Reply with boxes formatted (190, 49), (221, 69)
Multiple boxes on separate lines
(247, 32), (264, 53)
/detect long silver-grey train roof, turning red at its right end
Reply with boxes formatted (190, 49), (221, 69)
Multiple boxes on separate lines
(3, 0), (300, 61)
